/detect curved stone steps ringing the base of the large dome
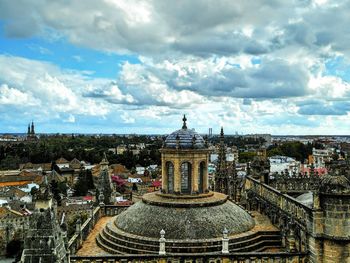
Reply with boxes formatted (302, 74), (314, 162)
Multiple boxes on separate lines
(96, 222), (281, 255)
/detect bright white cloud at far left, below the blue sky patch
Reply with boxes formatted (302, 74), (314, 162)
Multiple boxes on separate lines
(0, 55), (109, 116)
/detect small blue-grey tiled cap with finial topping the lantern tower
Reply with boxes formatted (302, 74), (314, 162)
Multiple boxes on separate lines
(164, 116), (206, 149)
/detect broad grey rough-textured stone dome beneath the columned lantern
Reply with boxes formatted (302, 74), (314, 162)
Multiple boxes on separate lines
(115, 193), (255, 239)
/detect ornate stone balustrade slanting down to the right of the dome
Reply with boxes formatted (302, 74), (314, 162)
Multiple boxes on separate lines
(245, 176), (313, 227)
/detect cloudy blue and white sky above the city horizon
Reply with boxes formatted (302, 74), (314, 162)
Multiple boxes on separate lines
(0, 0), (350, 134)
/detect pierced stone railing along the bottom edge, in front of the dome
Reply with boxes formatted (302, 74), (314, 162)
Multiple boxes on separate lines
(70, 252), (307, 263)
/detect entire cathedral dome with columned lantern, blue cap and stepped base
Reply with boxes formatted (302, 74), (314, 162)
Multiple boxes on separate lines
(97, 116), (256, 254)
